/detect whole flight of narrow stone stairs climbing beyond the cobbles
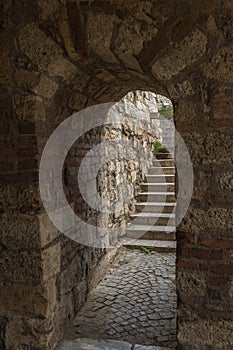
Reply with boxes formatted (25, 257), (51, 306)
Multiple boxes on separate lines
(124, 148), (176, 252)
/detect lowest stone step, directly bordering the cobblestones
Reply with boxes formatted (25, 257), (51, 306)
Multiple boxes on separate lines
(124, 239), (176, 253)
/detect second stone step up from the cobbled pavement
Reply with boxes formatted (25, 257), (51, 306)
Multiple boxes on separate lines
(126, 225), (176, 241)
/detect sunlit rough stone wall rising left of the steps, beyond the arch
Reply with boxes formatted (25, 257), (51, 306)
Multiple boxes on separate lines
(98, 91), (158, 243)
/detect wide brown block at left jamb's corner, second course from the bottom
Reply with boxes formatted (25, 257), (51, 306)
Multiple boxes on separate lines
(0, 279), (56, 317)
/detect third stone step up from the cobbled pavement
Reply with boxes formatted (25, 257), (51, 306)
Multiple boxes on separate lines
(130, 213), (175, 226)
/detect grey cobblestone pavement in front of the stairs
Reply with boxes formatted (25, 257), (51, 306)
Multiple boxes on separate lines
(61, 249), (176, 349)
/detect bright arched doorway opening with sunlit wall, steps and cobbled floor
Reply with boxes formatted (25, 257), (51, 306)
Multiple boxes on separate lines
(56, 91), (177, 349)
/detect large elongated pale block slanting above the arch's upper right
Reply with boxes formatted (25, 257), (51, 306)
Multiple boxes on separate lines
(152, 29), (207, 80)
